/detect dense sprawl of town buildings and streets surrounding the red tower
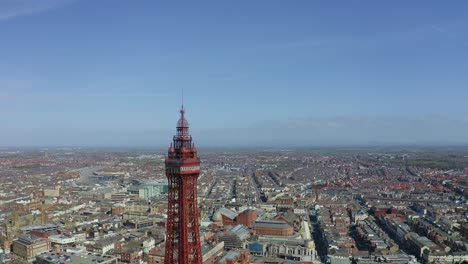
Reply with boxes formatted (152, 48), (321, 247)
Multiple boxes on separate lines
(0, 148), (468, 264)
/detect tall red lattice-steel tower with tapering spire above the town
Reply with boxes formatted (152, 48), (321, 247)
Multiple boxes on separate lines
(164, 105), (202, 264)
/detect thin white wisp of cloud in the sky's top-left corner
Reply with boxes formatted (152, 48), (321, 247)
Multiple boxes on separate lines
(0, 0), (76, 21)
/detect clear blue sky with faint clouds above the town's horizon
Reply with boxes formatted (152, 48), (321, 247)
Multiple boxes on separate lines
(0, 0), (468, 146)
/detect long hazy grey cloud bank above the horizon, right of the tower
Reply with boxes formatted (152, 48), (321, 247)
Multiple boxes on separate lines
(206, 114), (468, 146)
